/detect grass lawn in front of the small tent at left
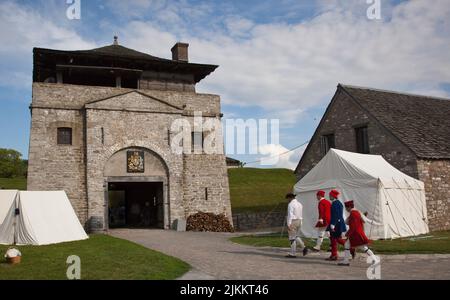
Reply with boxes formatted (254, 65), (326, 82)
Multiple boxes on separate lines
(0, 234), (190, 280)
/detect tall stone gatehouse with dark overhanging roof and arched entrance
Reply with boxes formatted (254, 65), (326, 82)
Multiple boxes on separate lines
(28, 38), (232, 231)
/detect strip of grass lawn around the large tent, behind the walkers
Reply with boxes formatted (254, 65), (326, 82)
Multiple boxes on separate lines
(231, 231), (450, 254)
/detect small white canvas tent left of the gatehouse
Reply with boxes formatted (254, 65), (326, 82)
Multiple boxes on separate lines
(0, 190), (88, 245)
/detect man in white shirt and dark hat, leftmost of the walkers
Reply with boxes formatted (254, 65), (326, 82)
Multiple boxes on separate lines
(286, 194), (308, 258)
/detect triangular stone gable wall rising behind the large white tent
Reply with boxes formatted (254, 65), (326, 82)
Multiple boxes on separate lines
(296, 90), (418, 180)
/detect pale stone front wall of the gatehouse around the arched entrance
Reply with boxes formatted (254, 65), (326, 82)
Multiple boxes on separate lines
(28, 83), (231, 230)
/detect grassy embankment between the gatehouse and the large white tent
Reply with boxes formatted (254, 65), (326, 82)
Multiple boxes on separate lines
(228, 168), (296, 213)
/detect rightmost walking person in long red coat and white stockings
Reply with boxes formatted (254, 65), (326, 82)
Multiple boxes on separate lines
(339, 201), (379, 266)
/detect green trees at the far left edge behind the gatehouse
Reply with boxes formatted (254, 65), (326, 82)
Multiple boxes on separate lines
(0, 148), (27, 178)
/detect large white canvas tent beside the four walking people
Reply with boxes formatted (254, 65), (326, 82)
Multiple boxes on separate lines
(294, 149), (429, 239)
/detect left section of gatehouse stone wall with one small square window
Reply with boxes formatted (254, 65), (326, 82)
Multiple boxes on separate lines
(27, 109), (87, 224)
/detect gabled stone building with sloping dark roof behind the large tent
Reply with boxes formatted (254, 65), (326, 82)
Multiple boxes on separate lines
(295, 85), (450, 230)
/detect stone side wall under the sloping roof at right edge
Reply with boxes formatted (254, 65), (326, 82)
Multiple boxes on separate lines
(417, 159), (450, 230)
